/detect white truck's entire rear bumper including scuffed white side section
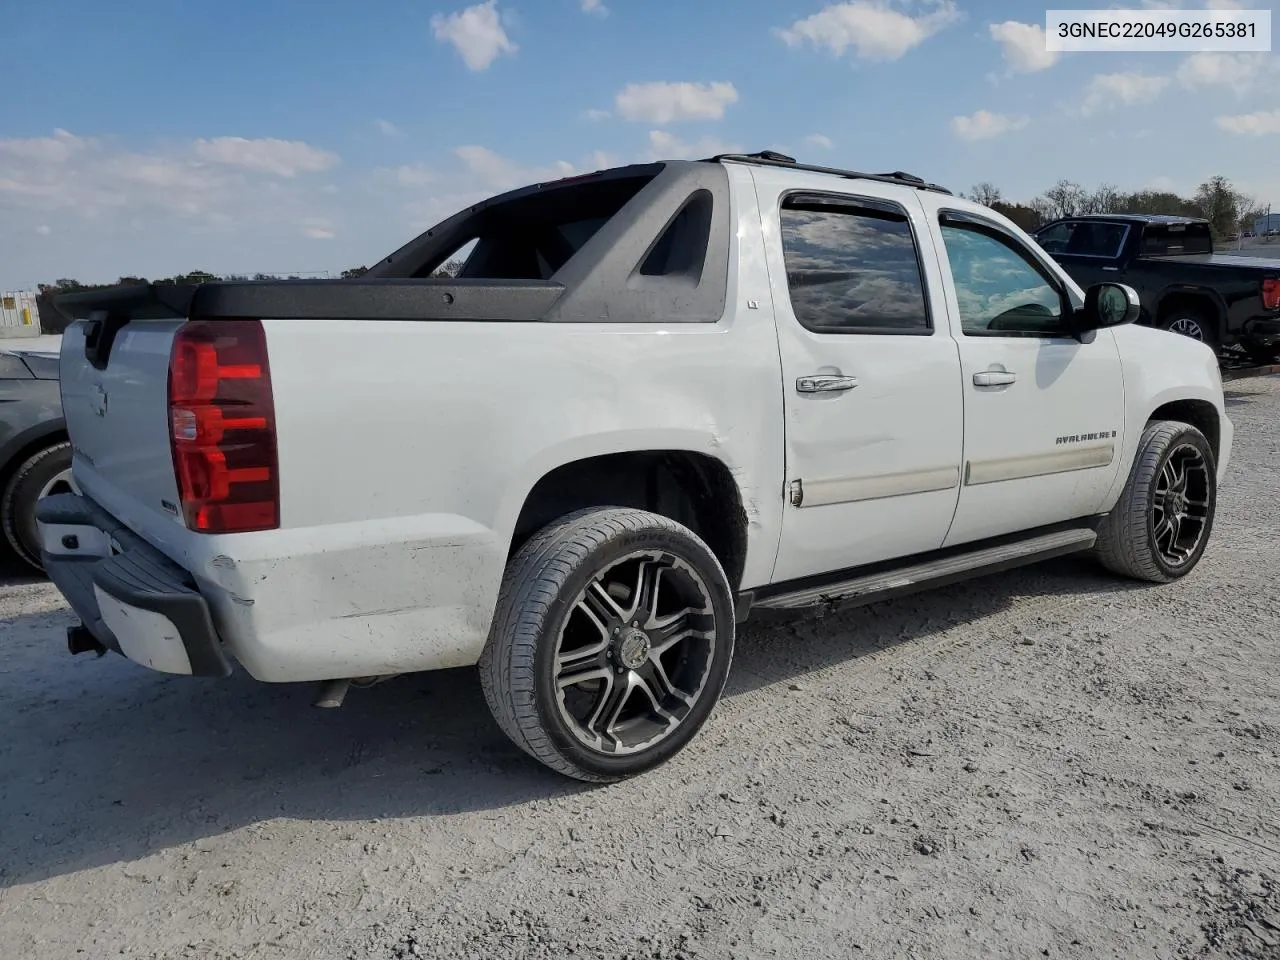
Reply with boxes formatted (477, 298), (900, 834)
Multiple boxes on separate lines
(37, 483), (506, 682)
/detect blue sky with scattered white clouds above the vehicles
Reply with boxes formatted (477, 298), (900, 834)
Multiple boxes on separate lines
(0, 0), (1280, 289)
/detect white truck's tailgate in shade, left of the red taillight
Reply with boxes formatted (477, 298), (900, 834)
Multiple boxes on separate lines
(59, 302), (186, 539)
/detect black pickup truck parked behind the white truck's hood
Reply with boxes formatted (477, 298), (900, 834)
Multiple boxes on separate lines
(1036, 214), (1280, 364)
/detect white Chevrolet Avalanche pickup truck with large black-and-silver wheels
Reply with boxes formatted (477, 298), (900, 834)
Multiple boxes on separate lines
(38, 152), (1233, 781)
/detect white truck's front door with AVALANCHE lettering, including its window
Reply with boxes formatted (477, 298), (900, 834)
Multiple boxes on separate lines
(922, 203), (1125, 547)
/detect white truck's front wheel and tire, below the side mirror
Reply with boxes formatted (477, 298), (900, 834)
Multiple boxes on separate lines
(1094, 420), (1217, 584)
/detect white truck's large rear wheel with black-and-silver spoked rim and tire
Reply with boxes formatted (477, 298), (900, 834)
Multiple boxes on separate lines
(479, 508), (736, 783)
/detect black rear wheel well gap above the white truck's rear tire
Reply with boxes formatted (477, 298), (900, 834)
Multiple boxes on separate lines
(508, 451), (746, 593)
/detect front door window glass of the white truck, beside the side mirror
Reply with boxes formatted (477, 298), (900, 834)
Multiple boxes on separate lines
(942, 224), (1064, 337)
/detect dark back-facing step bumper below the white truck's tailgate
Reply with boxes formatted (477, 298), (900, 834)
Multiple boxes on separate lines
(36, 494), (230, 677)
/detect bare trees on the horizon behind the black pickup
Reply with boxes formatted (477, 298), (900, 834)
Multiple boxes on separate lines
(961, 177), (1268, 241)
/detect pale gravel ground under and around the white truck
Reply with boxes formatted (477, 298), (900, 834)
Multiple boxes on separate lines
(0, 378), (1280, 960)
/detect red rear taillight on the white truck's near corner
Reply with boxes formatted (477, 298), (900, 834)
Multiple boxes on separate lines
(169, 319), (280, 534)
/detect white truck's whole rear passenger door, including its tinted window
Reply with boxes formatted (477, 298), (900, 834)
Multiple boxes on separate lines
(753, 166), (963, 582)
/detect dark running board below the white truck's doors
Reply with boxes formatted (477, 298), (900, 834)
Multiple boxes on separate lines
(751, 527), (1098, 611)
